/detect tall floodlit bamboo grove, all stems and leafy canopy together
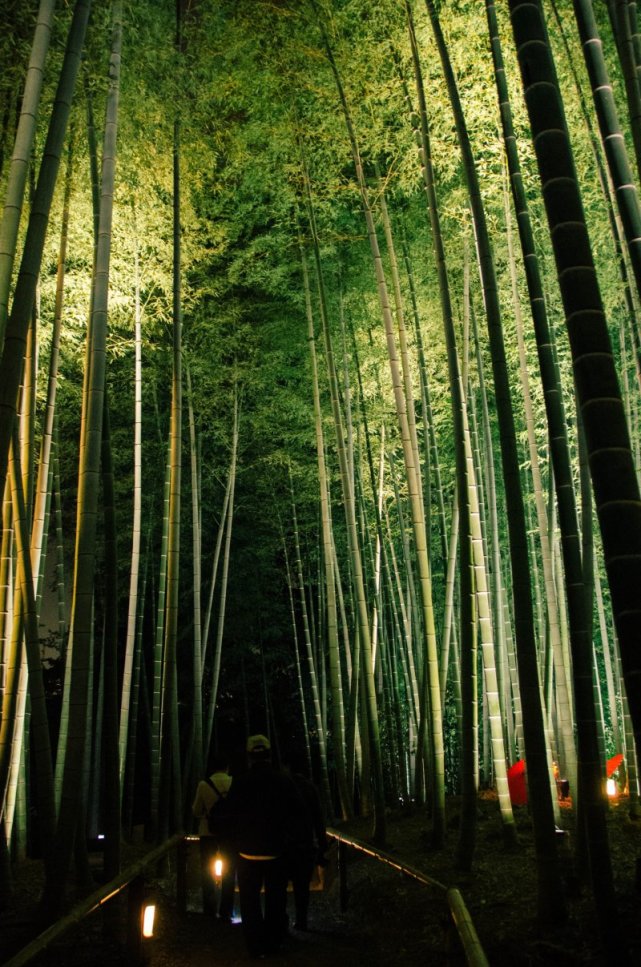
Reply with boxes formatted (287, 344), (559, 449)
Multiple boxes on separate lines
(0, 0), (641, 963)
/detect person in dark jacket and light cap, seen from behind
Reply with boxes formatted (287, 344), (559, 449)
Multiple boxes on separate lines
(228, 735), (305, 957)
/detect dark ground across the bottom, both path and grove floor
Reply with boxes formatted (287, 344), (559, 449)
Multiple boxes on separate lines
(5, 796), (641, 967)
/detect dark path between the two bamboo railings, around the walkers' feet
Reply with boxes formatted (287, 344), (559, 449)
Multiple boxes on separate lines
(2, 832), (465, 967)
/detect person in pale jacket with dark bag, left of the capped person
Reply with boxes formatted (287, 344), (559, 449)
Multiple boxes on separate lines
(192, 759), (236, 922)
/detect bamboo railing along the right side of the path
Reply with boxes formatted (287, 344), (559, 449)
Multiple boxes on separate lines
(327, 829), (489, 967)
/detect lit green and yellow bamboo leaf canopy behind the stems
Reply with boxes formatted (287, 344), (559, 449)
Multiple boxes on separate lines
(0, 0), (633, 840)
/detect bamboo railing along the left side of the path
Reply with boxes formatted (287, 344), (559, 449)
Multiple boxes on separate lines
(3, 833), (185, 967)
